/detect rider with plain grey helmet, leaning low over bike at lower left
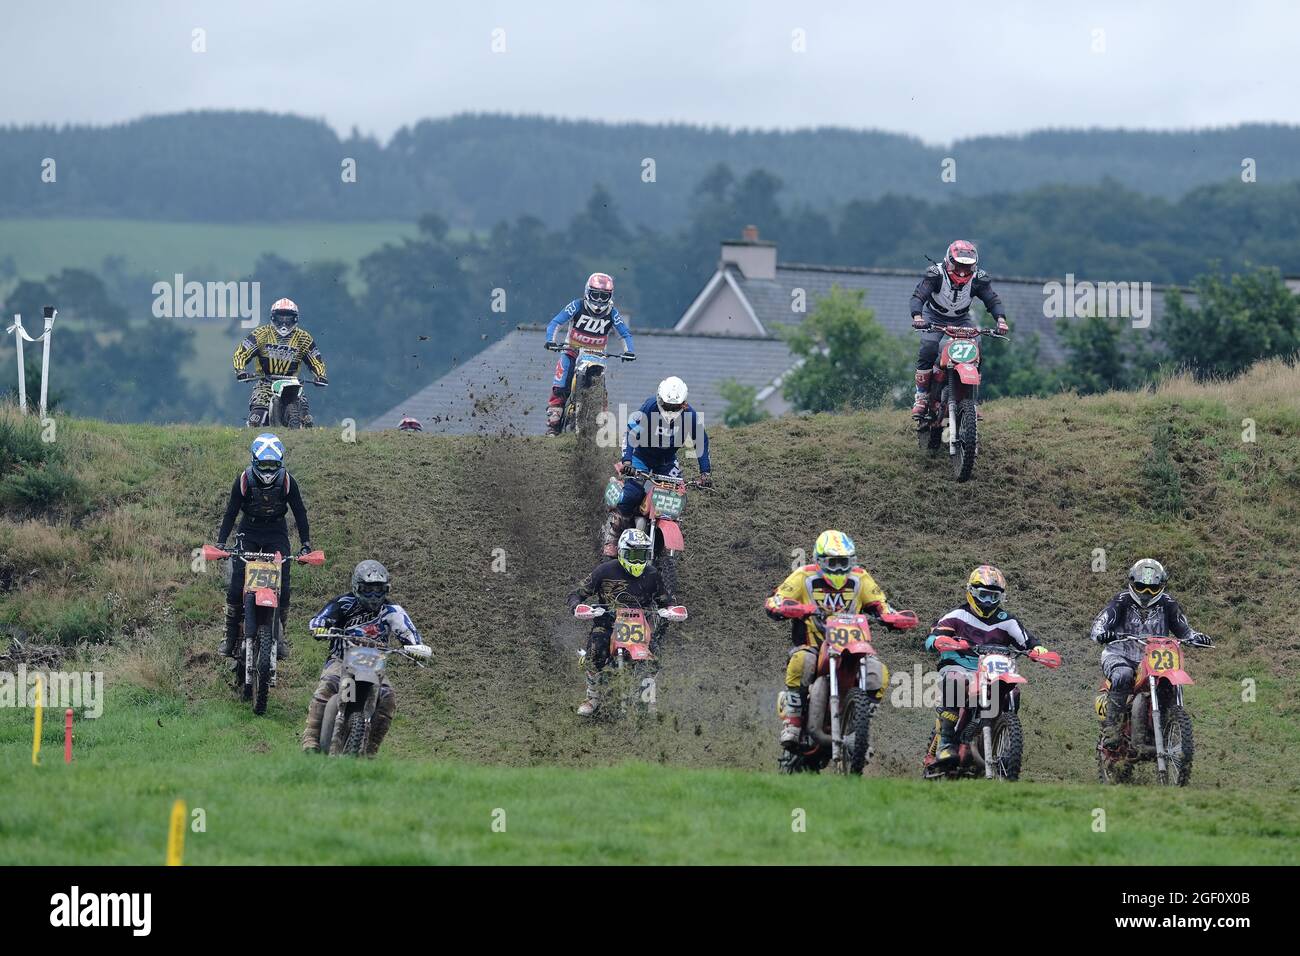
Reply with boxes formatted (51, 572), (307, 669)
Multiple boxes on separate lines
(302, 559), (424, 756)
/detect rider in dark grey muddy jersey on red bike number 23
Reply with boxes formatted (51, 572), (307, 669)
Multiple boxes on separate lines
(1092, 558), (1214, 757)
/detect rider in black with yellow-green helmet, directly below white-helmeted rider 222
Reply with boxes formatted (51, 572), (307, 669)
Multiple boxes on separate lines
(568, 528), (673, 717)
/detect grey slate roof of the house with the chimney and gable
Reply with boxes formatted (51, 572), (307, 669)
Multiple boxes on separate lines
(727, 263), (1196, 363)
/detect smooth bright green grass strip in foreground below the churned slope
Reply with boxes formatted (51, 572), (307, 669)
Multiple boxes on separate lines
(0, 692), (1300, 865)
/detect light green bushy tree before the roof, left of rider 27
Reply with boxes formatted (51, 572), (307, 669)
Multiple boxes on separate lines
(781, 286), (910, 411)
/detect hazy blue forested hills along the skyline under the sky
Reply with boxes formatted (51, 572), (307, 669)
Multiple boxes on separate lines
(0, 112), (1300, 229)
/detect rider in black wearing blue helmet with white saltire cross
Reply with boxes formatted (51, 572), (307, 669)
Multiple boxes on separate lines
(217, 432), (312, 659)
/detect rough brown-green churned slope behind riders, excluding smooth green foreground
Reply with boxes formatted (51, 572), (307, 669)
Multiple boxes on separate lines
(0, 364), (1300, 861)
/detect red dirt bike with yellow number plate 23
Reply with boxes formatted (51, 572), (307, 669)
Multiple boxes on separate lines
(1096, 635), (1213, 787)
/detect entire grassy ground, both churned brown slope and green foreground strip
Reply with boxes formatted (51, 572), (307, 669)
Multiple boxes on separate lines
(0, 363), (1300, 862)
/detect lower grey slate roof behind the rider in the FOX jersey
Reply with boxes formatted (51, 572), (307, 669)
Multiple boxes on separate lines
(367, 325), (794, 434)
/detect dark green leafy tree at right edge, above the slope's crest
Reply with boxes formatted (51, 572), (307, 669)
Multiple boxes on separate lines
(1164, 268), (1300, 378)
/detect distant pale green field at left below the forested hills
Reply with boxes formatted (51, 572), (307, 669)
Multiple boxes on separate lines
(0, 219), (416, 287)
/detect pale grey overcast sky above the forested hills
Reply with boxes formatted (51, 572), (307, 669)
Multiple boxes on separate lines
(0, 0), (1300, 147)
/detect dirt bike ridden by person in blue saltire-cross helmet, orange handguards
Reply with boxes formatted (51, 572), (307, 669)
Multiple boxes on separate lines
(203, 538), (325, 715)
